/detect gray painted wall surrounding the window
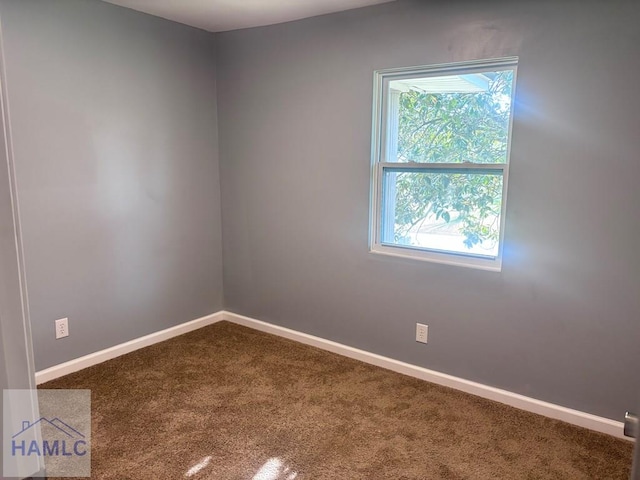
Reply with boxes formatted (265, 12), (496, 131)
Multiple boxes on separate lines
(218, 0), (640, 420)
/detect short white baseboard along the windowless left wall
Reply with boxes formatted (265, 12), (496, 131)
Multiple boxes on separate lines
(36, 310), (224, 385)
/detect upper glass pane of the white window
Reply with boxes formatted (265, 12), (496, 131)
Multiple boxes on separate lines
(387, 70), (514, 163)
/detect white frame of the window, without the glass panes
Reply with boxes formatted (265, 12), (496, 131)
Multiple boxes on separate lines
(369, 57), (518, 272)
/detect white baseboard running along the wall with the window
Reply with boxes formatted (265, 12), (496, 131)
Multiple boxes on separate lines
(223, 311), (631, 440)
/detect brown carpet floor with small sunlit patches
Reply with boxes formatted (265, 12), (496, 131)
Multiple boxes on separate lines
(41, 322), (632, 480)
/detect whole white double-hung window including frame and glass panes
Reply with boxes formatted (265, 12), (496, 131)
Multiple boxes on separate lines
(370, 57), (517, 270)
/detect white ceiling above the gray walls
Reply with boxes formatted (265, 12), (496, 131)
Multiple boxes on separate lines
(104, 0), (394, 32)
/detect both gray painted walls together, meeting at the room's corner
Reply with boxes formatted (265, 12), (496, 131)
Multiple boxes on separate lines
(0, 0), (640, 420)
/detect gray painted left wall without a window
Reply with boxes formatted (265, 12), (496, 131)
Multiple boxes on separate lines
(0, 0), (222, 370)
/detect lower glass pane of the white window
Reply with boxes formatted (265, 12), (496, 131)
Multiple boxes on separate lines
(381, 169), (503, 257)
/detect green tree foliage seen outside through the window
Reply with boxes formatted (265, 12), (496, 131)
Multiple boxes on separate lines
(394, 70), (513, 248)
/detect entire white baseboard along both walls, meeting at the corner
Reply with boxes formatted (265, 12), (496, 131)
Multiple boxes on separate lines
(36, 310), (631, 440)
